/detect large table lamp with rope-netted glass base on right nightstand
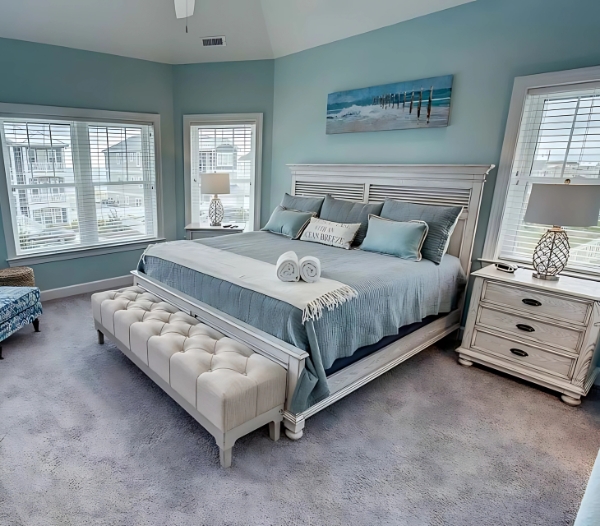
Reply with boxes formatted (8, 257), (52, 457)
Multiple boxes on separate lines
(524, 179), (600, 281)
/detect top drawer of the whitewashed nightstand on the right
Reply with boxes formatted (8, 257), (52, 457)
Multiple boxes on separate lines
(481, 281), (592, 325)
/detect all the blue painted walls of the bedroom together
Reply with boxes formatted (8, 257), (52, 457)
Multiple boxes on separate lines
(0, 0), (600, 289)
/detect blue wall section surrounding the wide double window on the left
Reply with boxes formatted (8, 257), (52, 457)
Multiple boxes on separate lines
(0, 39), (178, 289)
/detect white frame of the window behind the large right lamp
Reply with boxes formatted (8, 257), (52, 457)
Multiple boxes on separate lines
(479, 66), (600, 279)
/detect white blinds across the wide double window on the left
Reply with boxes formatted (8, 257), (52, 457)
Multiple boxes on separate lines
(0, 117), (157, 256)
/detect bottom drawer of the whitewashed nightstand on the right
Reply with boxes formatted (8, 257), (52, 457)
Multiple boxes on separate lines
(472, 328), (575, 378)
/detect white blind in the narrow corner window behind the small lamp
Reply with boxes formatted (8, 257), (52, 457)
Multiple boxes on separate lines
(190, 124), (257, 230)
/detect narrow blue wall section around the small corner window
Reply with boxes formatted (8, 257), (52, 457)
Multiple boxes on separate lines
(173, 60), (274, 237)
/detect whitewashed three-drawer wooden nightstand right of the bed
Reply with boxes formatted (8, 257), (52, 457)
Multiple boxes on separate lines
(456, 265), (600, 405)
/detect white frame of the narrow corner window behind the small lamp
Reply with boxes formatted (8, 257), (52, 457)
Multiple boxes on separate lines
(183, 113), (263, 230)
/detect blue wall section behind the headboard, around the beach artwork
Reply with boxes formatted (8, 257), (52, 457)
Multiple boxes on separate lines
(269, 0), (600, 257)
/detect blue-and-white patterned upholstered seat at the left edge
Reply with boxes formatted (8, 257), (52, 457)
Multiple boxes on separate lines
(0, 287), (42, 360)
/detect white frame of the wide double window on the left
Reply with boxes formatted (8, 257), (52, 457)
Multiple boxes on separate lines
(0, 103), (164, 267)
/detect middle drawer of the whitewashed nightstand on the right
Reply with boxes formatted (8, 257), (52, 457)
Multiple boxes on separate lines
(476, 306), (584, 352)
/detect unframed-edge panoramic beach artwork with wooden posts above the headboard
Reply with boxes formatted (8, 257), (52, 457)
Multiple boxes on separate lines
(327, 75), (454, 134)
